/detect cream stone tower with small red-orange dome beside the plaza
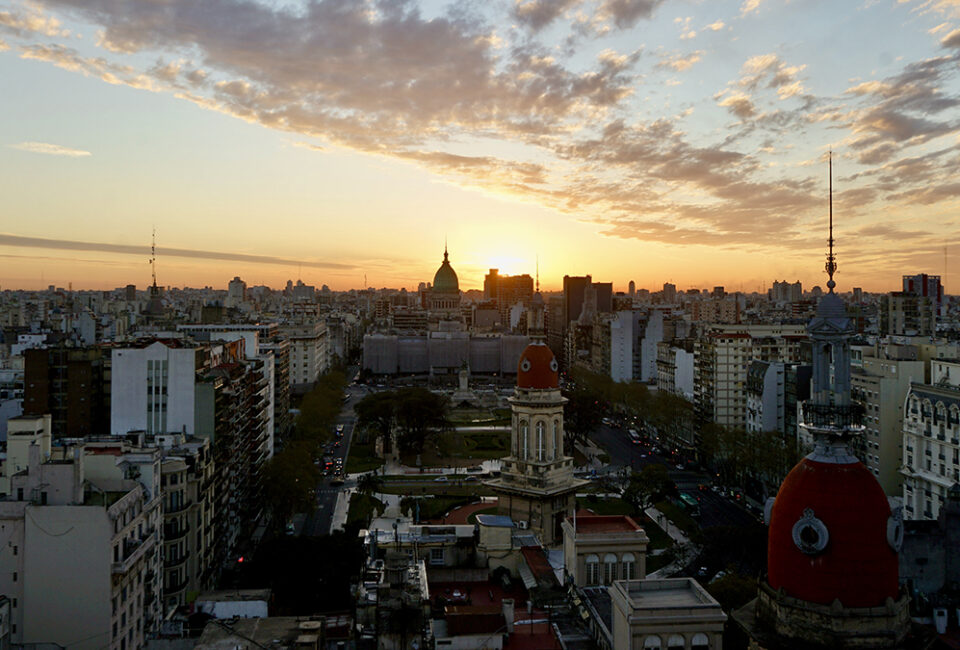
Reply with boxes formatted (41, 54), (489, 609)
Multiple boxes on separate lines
(487, 339), (589, 546)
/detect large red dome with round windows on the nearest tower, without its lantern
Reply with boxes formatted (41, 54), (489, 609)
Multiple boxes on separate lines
(767, 458), (902, 607)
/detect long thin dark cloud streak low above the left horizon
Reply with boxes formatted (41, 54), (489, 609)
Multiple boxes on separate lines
(0, 233), (357, 269)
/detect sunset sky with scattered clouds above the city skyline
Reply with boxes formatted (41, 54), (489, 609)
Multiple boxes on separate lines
(0, 0), (960, 293)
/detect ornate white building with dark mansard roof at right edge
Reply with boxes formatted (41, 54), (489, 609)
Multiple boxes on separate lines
(901, 360), (960, 520)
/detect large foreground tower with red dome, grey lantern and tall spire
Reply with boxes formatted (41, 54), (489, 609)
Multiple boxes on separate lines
(751, 154), (910, 648)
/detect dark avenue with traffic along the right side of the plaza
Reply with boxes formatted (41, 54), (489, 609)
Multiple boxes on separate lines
(590, 424), (757, 528)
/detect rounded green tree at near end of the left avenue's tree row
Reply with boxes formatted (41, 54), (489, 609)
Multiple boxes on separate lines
(263, 441), (320, 529)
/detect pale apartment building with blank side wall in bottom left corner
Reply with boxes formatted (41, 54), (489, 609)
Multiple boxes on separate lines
(0, 444), (160, 650)
